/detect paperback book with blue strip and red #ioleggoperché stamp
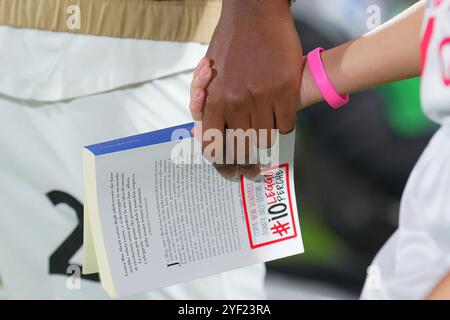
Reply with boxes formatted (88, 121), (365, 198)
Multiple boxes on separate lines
(83, 124), (303, 298)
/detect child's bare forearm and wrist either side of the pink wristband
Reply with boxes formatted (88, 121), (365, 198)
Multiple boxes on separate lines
(301, 1), (424, 107)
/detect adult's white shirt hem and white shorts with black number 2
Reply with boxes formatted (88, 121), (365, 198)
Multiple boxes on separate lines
(0, 26), (265, 299)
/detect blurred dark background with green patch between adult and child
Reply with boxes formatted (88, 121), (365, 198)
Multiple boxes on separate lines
(268, 0), (436, 298)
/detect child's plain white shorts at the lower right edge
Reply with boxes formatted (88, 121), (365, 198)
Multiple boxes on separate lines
(362, 127), (450, 299)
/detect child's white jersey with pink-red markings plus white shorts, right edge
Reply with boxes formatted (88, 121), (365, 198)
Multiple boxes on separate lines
(362, 0), (450, 299)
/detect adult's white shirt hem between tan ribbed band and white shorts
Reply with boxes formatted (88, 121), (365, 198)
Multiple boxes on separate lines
(0, 26), (207, 101)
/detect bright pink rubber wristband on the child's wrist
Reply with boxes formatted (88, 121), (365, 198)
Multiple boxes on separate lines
(306, 48), (350, 109)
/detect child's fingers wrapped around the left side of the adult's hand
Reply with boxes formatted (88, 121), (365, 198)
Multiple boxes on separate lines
(189, 57), (212, 141)
